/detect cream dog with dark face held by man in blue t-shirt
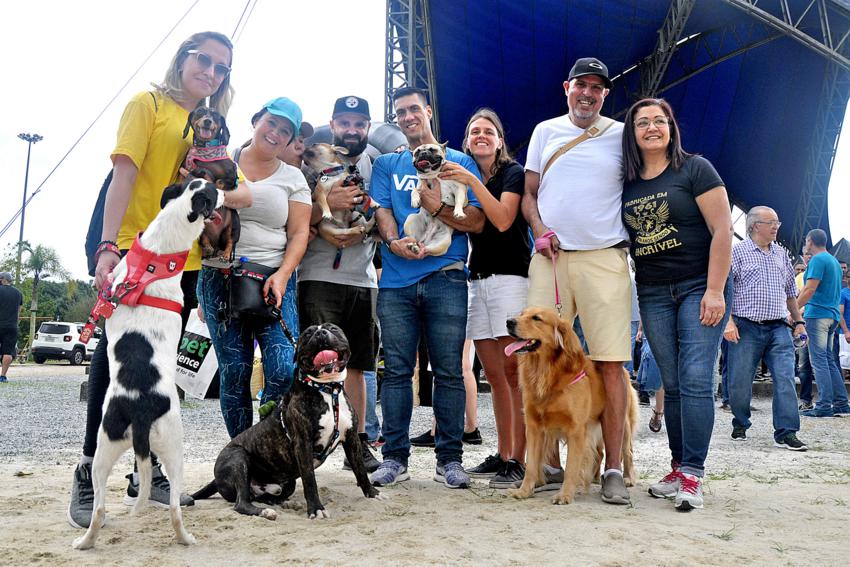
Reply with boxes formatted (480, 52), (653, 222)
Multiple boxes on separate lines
(404, 144), (469, 256)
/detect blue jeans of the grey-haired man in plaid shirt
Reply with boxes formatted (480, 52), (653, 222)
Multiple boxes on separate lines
(728, 317), (800, 441)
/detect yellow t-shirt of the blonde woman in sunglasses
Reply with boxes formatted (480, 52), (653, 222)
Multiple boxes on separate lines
(111, 91), (201, 270)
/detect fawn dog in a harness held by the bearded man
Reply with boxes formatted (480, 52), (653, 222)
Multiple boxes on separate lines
(302, 144), (377, 245)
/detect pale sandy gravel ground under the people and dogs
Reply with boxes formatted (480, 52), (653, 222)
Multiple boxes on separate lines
(0, 369), (850, 566)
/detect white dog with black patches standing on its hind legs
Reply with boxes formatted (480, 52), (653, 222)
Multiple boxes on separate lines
(73, 179), (224, 549)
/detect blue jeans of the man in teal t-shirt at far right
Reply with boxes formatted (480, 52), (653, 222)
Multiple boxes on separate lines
(806, 317), (847, 414)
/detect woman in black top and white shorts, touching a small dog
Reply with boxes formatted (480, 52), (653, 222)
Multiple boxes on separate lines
(440, 108), (531, 488)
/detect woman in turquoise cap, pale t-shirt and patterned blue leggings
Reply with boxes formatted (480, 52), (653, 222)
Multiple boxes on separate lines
(198, 97), (312, 437)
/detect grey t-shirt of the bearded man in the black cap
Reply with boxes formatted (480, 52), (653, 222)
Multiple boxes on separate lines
(298, 152), (378, 288)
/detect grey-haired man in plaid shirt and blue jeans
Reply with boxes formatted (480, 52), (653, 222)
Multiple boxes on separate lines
(723, 207), (807, 451)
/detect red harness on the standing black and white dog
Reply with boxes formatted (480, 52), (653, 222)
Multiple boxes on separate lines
(80, 232), (189, 344)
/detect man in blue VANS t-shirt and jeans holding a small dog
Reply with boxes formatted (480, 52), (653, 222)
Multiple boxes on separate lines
(370, 88), (484, 488)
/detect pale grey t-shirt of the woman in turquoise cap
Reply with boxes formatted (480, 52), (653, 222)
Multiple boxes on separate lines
(236, 162), (312, 268)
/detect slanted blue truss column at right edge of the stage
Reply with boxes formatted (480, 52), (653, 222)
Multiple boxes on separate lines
(791, 65), (850, 246)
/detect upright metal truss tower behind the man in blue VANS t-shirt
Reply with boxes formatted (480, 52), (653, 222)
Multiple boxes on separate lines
(384, 0), (440, 140)
